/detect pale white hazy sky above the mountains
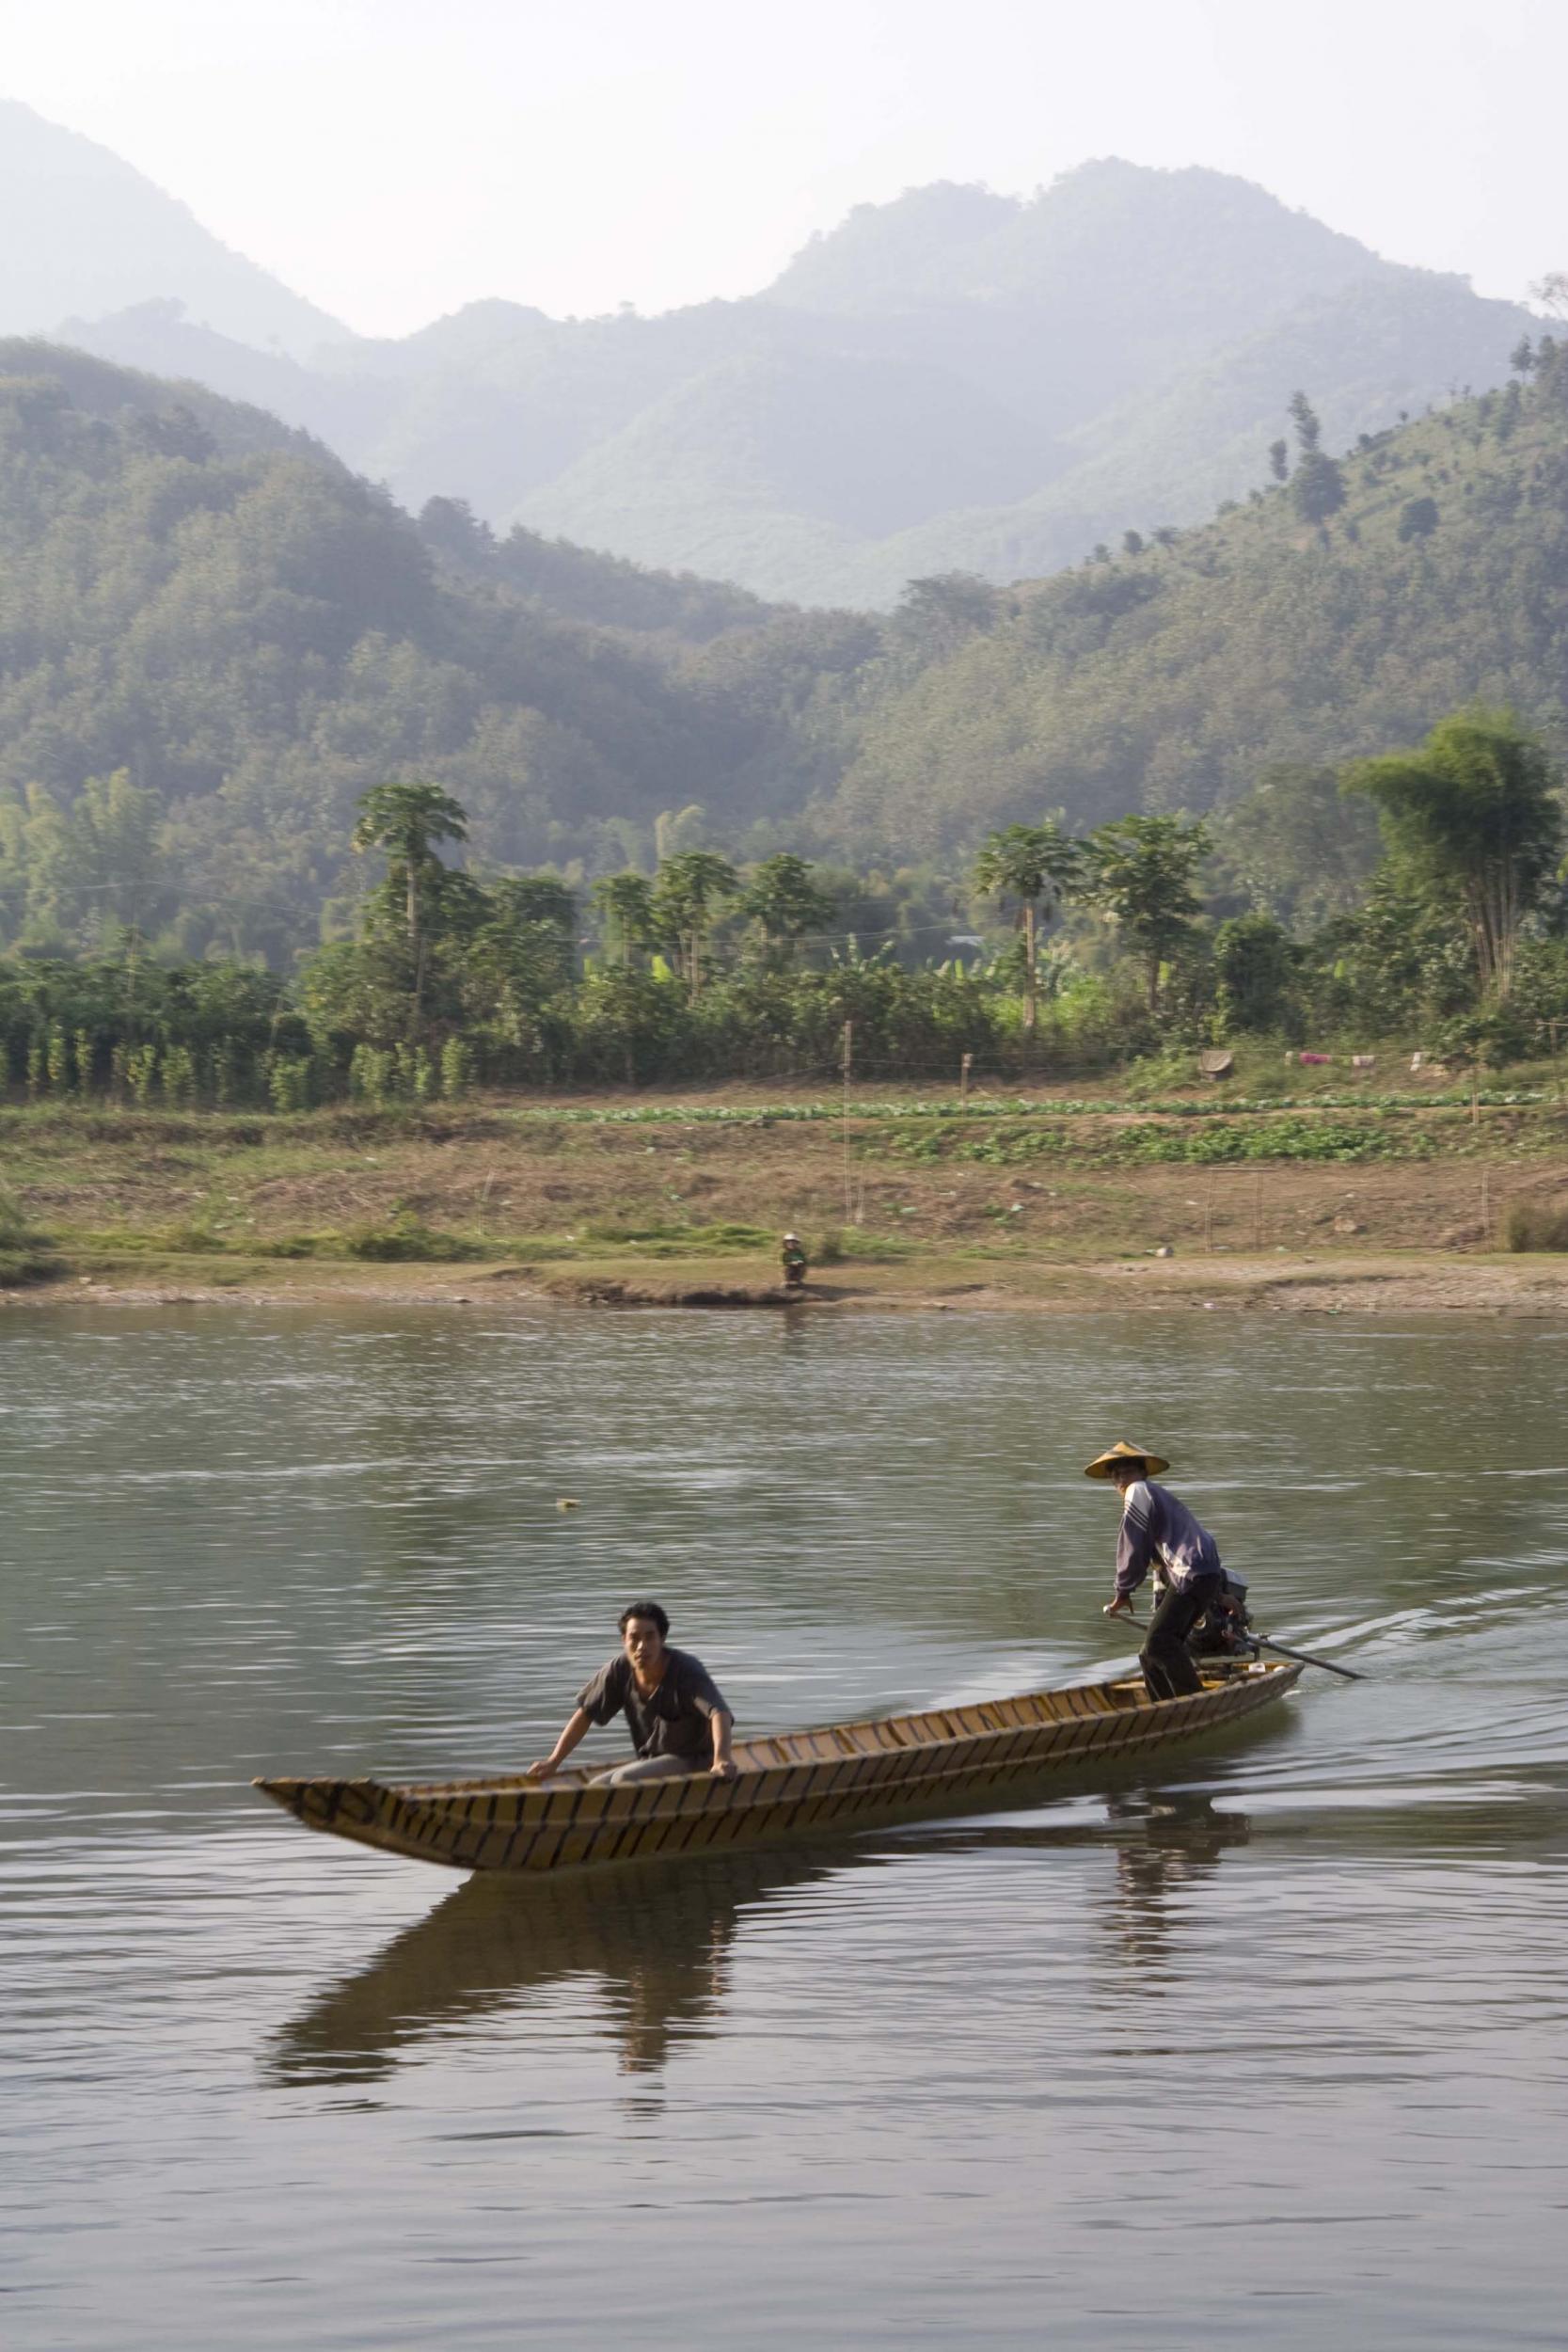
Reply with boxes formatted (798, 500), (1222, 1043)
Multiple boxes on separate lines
(0, 0), (1568, 334)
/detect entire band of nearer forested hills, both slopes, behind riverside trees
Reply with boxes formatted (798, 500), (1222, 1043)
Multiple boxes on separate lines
(0, 342), (1568, 962)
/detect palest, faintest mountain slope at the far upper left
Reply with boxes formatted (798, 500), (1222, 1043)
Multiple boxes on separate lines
(0, 99), (348, 358)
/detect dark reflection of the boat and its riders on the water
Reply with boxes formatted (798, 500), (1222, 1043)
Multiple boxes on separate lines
(268, 1795), (1251, 2084)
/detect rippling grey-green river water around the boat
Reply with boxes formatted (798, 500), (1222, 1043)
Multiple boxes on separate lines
(0, 1306), (1568, 2352)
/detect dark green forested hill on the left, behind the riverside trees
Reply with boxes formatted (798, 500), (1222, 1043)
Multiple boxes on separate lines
(0, 343), (877, 958)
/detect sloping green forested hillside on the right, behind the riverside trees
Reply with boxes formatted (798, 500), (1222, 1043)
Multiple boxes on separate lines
(820, 339), (1568, 856)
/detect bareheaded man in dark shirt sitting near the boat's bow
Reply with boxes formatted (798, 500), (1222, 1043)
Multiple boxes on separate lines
(529, 1602), (736, 1786)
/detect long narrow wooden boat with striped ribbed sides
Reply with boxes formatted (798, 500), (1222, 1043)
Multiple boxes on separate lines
(256, 1661), (1300, 1872)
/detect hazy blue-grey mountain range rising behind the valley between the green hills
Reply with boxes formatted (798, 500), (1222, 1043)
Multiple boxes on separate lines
(71, 163), (1533, 607)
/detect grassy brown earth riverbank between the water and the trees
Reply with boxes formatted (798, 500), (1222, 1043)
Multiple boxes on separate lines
(0, 1089), (1568, 1315)
